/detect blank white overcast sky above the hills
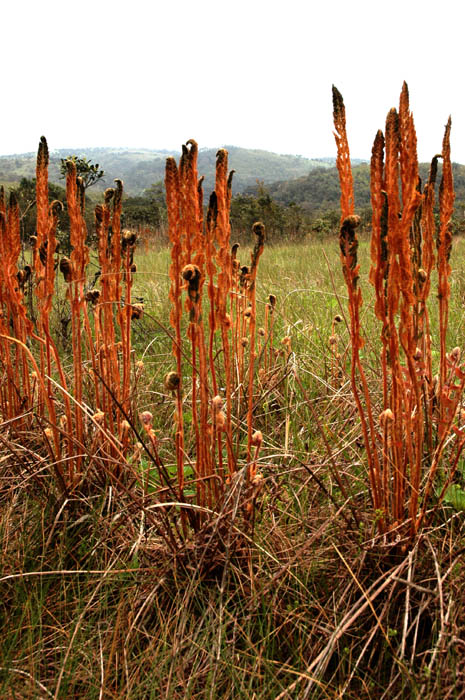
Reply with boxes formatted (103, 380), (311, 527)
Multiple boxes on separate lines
(0, 0), (465, 163)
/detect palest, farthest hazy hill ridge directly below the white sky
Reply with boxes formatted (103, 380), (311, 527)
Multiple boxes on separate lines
(0, 146), (334, 195)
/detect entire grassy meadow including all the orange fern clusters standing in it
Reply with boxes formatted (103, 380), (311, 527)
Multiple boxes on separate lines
(0, 87), (465, 700)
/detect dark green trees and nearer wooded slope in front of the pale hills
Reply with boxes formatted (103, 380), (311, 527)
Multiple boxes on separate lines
(8, 156), (465, 254)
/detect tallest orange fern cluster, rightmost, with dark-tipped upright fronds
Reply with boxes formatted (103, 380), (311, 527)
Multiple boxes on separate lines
(333, 83), (465, 538)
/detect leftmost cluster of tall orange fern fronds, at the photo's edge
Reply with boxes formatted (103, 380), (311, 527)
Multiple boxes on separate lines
(0, 137), (135, 489)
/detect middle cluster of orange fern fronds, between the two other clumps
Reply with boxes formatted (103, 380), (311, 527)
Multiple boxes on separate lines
(165, 140), (269, 507)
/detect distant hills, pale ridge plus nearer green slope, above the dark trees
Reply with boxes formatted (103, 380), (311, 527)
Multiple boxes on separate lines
(0, 145), (465, 215)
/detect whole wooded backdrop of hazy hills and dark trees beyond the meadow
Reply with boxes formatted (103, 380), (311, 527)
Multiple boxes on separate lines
(0, 146), (465, 245)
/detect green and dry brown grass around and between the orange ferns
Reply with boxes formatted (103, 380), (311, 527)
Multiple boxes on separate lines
(0, 241), (465, 700)
